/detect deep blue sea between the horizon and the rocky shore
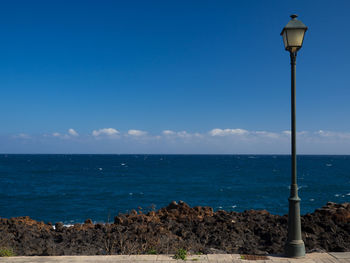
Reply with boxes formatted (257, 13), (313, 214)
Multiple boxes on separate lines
(0, 154), (350, 224)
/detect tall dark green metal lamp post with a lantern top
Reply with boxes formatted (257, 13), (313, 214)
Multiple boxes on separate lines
(281, 15), (307, 258)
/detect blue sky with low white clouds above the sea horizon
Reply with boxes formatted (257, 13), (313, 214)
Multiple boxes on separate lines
(0, 0), (350, 154)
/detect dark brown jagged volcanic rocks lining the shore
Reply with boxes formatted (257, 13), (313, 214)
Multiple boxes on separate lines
(0, 201), (350, 256)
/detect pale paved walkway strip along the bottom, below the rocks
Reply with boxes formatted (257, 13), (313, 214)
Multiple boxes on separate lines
(0, 255), (350, 263)
